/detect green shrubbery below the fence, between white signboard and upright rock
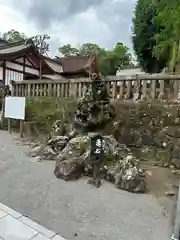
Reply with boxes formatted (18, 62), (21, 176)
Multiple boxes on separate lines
(26, 97), (76, 133)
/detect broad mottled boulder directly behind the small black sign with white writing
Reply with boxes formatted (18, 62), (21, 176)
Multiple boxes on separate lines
(54, 135), (146, 192)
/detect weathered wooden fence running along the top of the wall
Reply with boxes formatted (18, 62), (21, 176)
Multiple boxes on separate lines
(13, 75), (180, 100)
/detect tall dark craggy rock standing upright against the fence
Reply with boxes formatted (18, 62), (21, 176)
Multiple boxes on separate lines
(74, 75), (115, 133)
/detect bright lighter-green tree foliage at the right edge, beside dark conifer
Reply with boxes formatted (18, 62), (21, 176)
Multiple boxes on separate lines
(154, 0), (180, 73)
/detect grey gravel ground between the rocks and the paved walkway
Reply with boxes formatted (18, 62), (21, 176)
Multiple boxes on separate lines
(0, 131), (172, 240)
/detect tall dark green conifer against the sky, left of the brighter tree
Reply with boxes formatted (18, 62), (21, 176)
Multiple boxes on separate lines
(132, 0), (166, 73)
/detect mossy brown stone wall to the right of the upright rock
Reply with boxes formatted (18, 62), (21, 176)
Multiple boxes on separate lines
(112, 102), (180, 168)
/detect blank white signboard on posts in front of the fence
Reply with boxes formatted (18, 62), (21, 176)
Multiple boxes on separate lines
(4, 97), (25, 120)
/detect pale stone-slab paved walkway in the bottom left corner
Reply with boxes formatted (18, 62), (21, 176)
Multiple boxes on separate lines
(0, 203), (65, 240)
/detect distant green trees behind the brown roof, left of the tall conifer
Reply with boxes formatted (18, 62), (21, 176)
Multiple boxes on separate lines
(59, 43), (132, 76)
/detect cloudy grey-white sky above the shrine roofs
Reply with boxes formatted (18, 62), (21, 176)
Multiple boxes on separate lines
(0, 0), (136, 55)
